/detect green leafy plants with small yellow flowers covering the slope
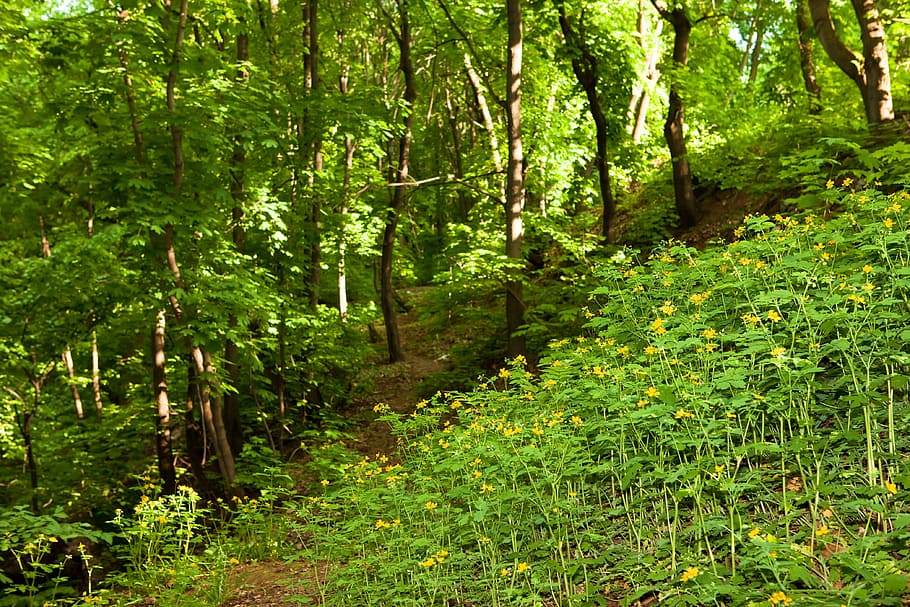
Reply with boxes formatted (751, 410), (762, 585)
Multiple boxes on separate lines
(7, 186), (910, 607)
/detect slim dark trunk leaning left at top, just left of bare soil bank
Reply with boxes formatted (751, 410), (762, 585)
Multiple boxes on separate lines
(554, 0), (616, 243)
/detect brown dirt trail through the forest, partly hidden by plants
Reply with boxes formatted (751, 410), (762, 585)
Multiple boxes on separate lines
(223, 287), (448, 607)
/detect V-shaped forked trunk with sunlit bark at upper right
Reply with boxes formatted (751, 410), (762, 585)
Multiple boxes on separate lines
(809, 0), (894, 125)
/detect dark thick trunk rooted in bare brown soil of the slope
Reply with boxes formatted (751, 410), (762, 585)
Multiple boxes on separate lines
(651, 0), (700, 228)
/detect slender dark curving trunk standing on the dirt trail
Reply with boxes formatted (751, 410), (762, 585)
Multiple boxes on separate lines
(379, 0), (417, 362)
